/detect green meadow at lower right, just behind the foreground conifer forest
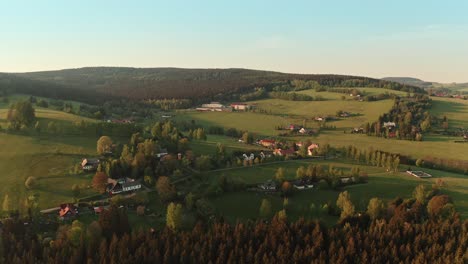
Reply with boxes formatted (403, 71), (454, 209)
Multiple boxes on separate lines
(205, 161), (468, 223)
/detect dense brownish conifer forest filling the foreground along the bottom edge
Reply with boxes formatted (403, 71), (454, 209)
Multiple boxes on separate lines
(0, 212), (468, 264)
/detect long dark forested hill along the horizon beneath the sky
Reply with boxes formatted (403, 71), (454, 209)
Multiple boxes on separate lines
(0, 67), (424, 101)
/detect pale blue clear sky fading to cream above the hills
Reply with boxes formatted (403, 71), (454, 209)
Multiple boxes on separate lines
(0, 0), (468, 82)
